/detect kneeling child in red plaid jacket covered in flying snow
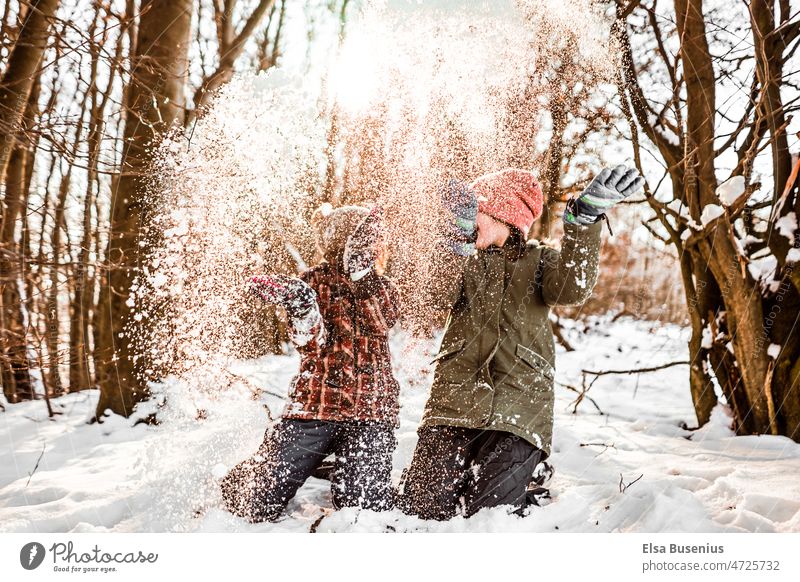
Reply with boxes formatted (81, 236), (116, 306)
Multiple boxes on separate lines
(222, 206), (399, 522)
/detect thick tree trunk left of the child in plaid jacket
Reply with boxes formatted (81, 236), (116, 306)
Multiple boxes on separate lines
(95, 0), (192, 417)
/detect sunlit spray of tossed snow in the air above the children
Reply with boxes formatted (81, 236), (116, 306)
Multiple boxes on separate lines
(134, 0), (616, 394)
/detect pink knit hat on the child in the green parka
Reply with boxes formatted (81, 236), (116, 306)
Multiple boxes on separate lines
(470, 168), (543, 239)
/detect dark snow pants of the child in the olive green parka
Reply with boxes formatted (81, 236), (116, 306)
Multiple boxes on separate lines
(400, 426), (546, 520)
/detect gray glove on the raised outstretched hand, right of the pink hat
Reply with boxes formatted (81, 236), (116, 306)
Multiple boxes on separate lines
(563, 165), (644, 225)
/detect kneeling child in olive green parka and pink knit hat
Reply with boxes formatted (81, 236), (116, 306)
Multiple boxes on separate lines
(401, 166), (644, 520)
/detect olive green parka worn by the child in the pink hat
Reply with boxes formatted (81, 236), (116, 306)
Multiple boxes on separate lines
(421, 222), (601, 455)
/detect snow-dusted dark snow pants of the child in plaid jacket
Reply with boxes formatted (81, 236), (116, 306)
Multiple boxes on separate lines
(221, 419), (397, 522)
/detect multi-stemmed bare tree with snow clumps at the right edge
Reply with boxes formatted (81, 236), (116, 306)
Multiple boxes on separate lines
(614, 0), (800, 440)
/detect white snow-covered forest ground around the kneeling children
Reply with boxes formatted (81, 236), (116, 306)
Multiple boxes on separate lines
(0, 319), (800, 532)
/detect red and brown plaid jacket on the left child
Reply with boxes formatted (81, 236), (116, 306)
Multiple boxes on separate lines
(284, 263), (400, 424)
